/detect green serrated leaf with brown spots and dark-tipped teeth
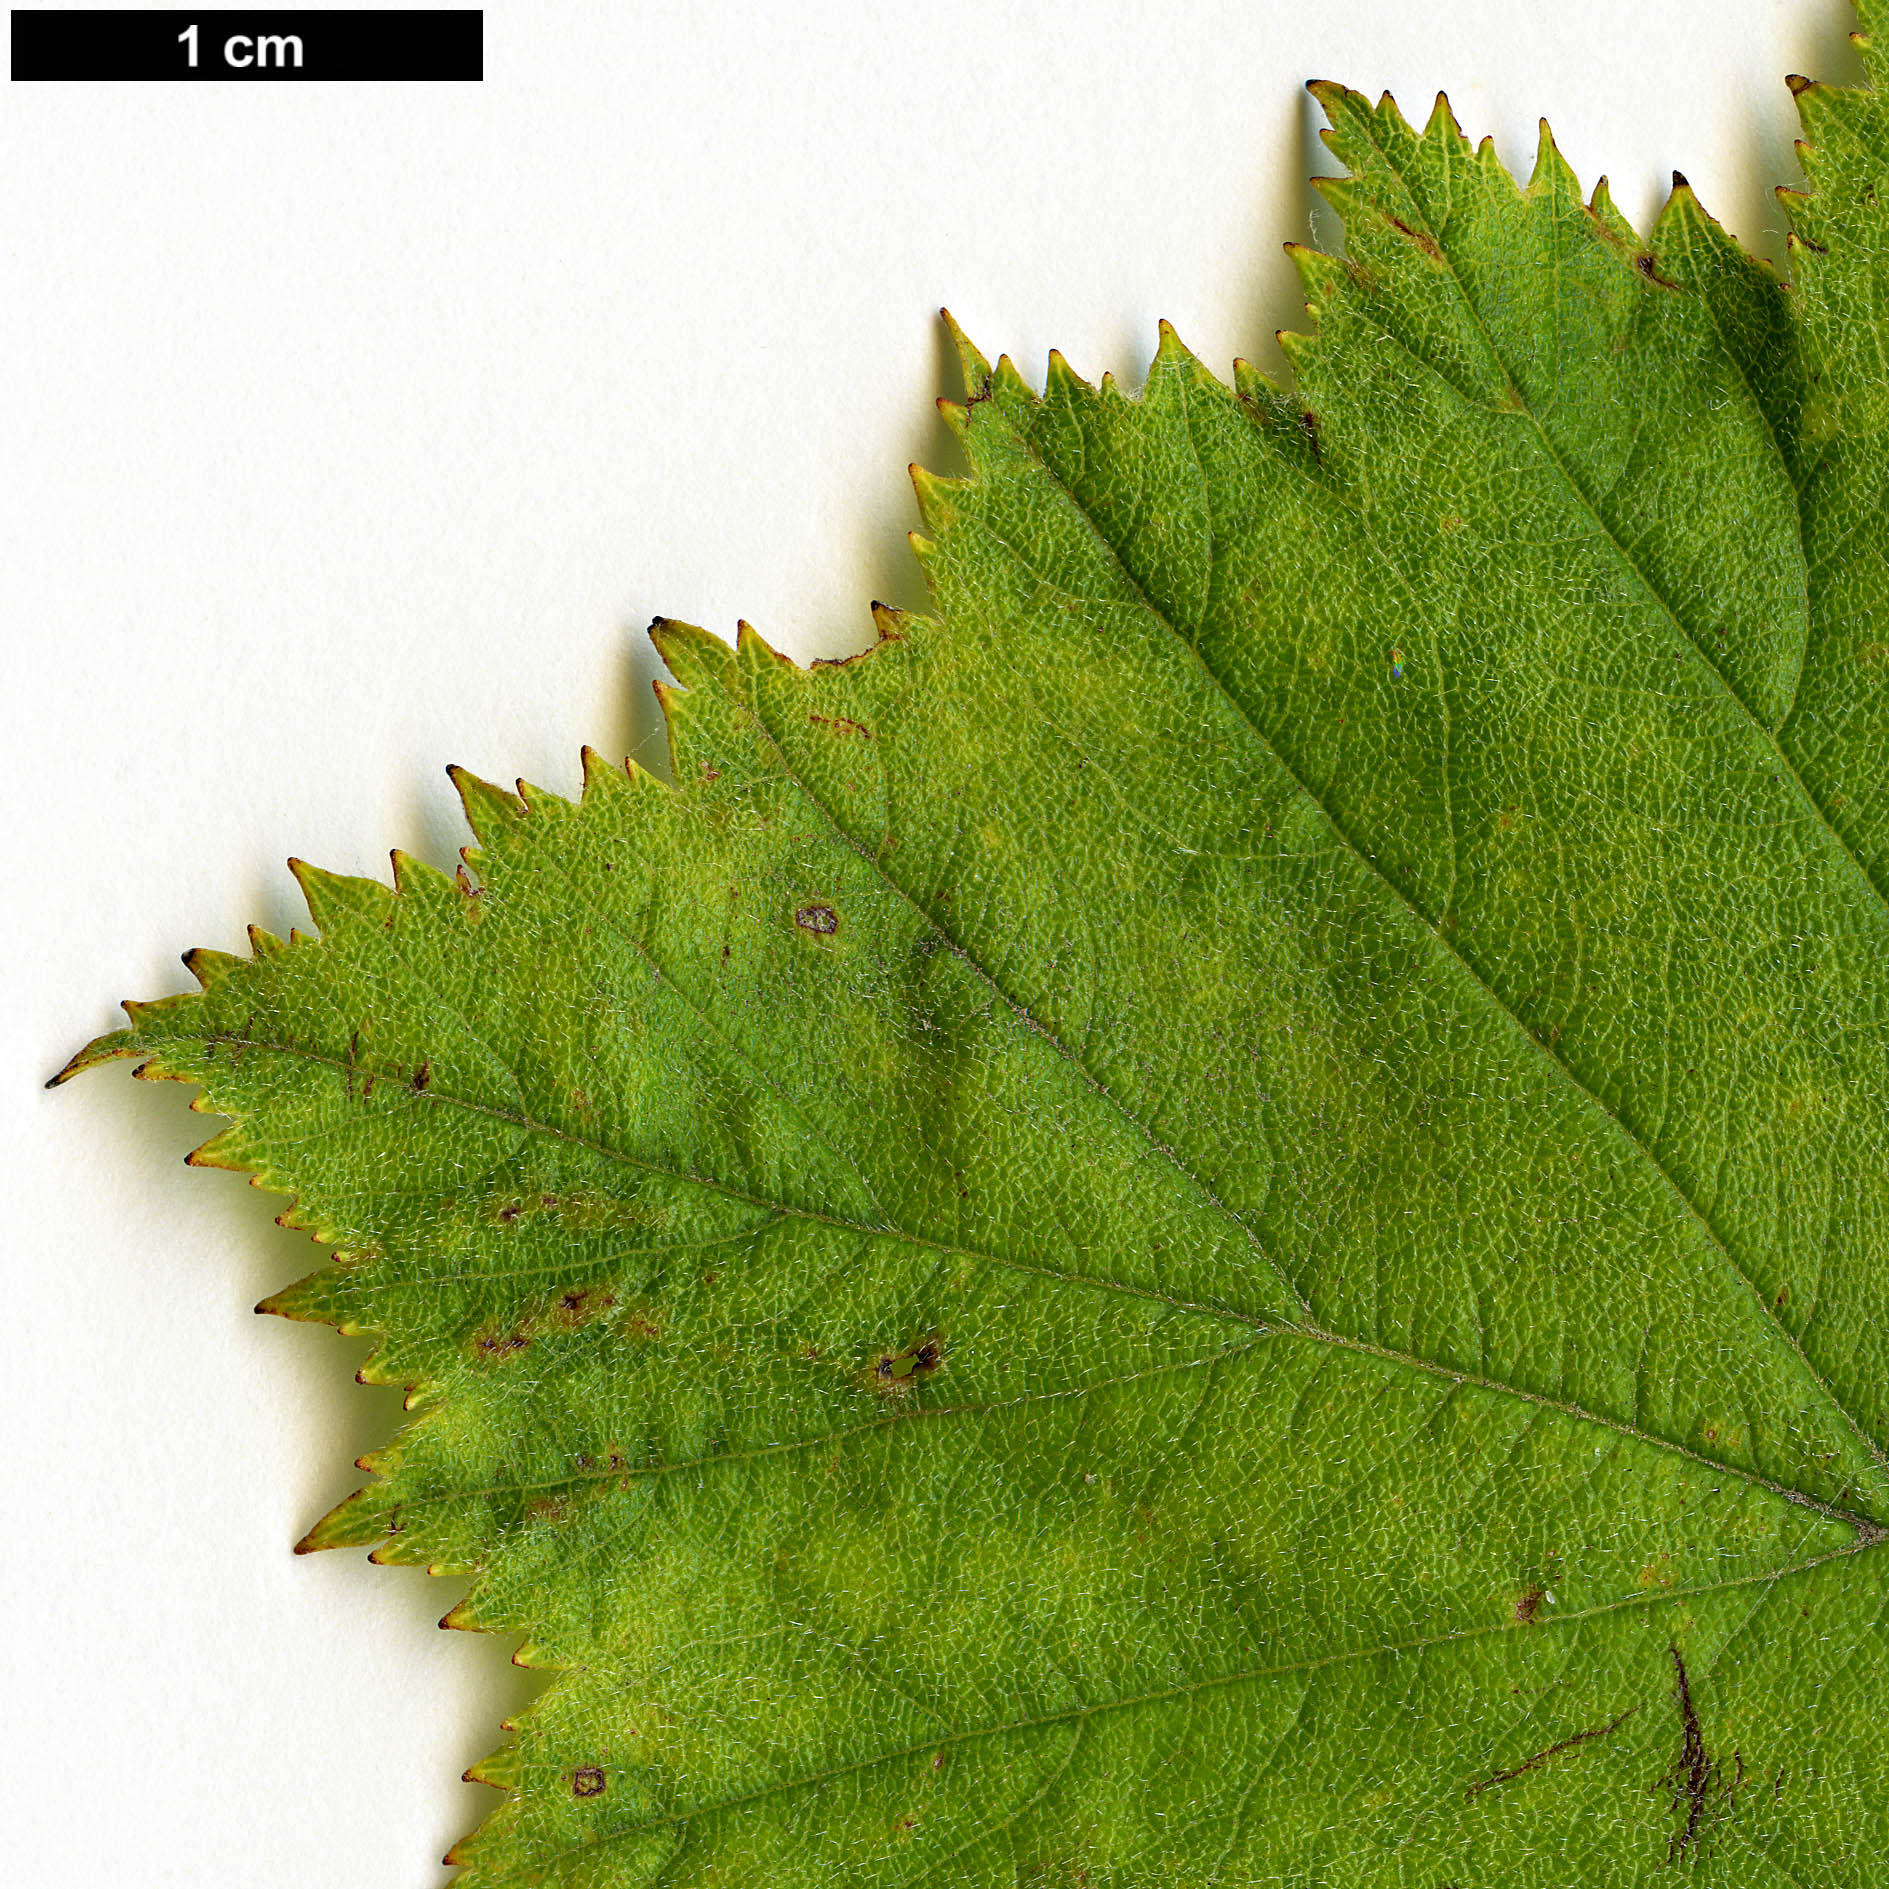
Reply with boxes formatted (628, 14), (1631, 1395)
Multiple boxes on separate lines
(55, 11), (1889, 1889)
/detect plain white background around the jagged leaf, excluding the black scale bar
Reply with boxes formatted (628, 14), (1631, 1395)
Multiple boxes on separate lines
(0, 0), (1857, 1889)
